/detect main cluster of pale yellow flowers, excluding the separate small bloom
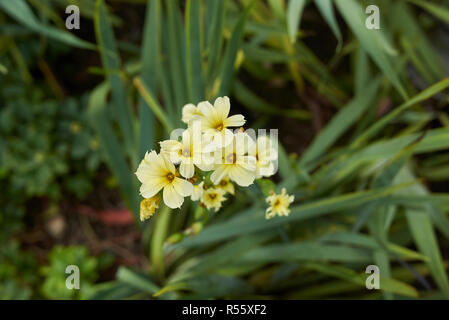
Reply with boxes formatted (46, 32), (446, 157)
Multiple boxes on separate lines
(136, 97), (290, 221)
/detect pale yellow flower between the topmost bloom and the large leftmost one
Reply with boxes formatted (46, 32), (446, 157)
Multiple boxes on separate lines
(160, 129), (213, 179)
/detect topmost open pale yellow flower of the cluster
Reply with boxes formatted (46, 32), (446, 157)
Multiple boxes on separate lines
(198, 97), (246, 147)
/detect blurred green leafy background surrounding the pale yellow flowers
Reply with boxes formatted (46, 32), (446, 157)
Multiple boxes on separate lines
(0, 0), (449, 299)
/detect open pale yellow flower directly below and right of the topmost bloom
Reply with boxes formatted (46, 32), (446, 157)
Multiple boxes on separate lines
(210, 132), (256, 187)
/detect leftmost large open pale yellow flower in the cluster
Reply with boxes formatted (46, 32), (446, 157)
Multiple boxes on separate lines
(136, 151), (193, 209)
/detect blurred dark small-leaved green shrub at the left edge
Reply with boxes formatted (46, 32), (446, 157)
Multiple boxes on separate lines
(0, 79), (100, 201)
